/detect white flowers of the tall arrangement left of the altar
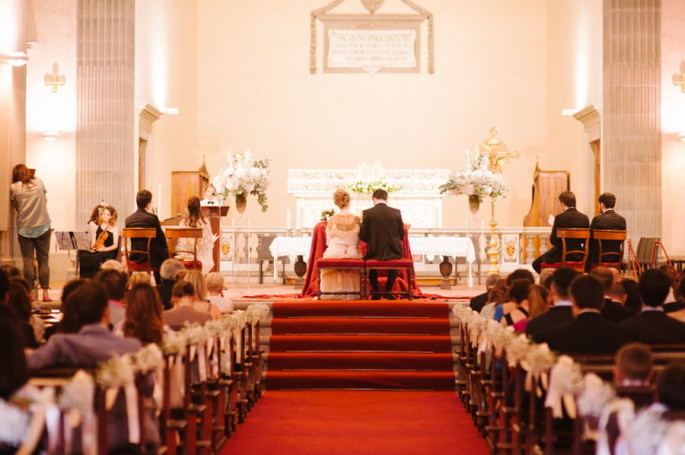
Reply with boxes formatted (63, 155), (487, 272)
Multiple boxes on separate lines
(212, 148), (269, 212)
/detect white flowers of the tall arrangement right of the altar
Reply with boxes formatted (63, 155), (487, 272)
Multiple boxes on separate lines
(440, 148), (510, 202)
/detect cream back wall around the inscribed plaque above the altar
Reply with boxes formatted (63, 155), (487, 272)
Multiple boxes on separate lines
(195, 0), (548, 227)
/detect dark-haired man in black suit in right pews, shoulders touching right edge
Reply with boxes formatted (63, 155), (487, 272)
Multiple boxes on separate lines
(621, 269), (685, 344)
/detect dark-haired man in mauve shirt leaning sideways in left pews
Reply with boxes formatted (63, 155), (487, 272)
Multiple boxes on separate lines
(27, 281), (159, 453)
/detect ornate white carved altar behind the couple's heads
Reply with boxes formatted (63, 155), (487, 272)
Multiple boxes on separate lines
(288, 162), (451, 228)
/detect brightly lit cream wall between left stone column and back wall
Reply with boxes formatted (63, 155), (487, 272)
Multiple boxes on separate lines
(134, 0), (196, 219)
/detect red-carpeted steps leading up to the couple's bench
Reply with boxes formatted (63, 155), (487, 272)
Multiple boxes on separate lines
(266, 300), (455, 390)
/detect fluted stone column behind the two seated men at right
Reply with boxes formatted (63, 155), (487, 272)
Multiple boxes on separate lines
(602, 0), (661, 242)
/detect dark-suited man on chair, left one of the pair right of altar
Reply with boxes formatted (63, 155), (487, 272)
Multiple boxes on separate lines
(532, 191), (590, 273)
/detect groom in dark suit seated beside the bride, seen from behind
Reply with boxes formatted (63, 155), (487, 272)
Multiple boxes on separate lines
(359, 189), (404, 300)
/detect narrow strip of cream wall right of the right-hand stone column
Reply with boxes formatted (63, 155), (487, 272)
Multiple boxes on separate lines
(661, 0), (685, 255)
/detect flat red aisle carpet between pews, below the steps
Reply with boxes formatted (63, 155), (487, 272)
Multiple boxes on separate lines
(216, 390), (489, 455)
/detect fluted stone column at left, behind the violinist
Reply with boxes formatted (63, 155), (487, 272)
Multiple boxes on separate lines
(75, 0), (135, 226)
